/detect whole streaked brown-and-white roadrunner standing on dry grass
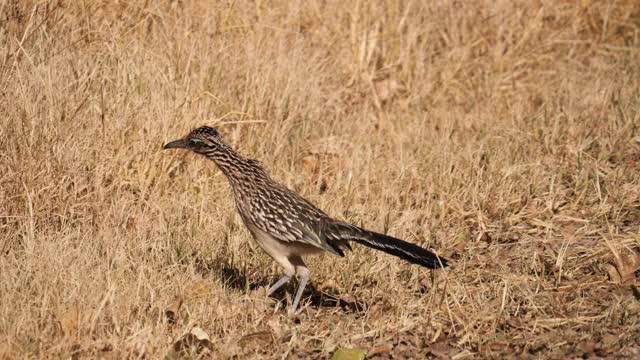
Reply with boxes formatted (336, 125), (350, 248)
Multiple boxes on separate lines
(163, 126), (447, 315)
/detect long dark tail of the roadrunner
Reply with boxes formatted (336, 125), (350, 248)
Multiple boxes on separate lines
(327, 223), (448, 269)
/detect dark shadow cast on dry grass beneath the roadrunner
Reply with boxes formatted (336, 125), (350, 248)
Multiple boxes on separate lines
(196, 259), (365, 314)
